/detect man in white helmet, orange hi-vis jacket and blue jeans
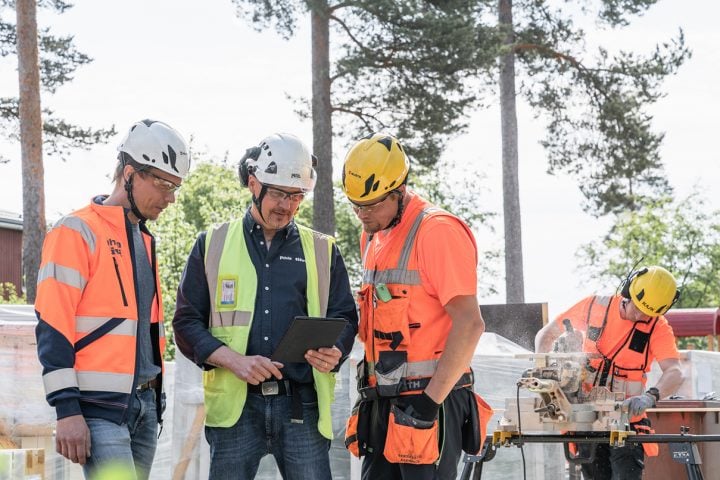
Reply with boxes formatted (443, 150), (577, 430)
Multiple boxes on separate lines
(35, 120), (190, 479)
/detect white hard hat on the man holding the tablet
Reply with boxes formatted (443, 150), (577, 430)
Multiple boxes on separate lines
(246, 133), (317, 192)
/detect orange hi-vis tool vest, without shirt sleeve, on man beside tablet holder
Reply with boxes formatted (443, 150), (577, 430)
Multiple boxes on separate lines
(358, 197), (472, 396)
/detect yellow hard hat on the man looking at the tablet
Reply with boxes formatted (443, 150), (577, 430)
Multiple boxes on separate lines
(342, 133), (410, 203)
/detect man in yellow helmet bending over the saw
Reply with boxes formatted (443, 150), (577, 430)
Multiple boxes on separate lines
(535, 266), (683, 480)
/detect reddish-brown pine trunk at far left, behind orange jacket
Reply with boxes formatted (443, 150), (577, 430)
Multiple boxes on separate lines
(16, 0), (46, 303)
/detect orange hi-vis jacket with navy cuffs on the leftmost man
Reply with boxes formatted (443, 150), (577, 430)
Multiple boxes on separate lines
(35, 197), (165, 424)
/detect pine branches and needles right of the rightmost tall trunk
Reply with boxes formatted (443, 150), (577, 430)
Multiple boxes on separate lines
(498, 0), (690, 216)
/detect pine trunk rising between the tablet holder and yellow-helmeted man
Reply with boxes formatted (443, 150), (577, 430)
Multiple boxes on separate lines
(311, 1), (335, 235)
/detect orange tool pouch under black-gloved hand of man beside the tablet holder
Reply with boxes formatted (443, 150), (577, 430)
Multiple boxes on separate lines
(383, 405), (440, 465)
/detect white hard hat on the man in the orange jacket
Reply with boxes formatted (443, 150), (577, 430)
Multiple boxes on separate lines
(118, 120), (190, 178)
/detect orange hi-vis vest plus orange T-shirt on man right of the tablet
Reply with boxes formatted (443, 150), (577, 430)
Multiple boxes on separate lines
(358, 195), (477, 398)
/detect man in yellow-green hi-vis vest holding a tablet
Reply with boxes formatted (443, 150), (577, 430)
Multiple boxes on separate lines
(173, 134), (357, 480)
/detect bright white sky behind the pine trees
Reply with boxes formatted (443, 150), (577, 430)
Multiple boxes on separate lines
(0, 0), (720, 315)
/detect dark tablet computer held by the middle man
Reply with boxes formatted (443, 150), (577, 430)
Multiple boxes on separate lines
(270, 317), (348, 363)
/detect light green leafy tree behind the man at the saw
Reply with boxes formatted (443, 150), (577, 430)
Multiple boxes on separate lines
(579, 193), (720, 308)
